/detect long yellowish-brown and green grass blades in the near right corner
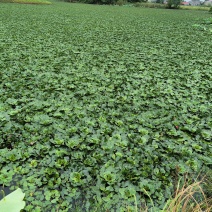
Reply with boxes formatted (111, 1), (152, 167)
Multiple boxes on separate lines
(127, 175), (212, 212)
